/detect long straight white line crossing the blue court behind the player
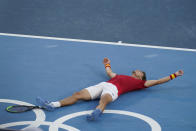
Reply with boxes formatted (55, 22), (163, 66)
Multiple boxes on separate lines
(0, 33), (196, 52)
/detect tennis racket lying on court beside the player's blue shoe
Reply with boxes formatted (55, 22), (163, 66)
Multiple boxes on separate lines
(6, 105), (45, 113)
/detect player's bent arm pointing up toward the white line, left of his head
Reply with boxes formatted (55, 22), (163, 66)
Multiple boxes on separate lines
(103, 58), (116, 78)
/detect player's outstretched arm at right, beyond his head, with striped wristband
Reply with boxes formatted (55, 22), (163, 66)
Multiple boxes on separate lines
(144, 70), (184, 87)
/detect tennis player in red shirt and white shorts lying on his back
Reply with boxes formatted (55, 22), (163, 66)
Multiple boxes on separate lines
(36, 58), (184, 120)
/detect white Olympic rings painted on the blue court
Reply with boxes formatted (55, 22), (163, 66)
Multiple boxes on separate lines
(0, 99), (161, 131)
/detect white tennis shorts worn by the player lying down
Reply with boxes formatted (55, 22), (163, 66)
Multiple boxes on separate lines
(85, 82), (118, 101)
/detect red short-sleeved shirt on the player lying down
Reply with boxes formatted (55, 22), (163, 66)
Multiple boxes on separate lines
(107, 75), (146, 96)
